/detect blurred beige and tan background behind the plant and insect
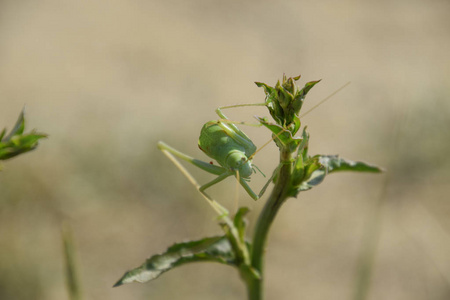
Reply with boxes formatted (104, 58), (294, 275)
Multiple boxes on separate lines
(0, 0), (450, 300)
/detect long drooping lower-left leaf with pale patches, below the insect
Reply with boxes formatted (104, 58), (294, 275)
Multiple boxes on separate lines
(114, 236), (235, 287)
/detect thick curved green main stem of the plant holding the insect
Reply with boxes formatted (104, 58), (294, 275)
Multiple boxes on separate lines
(246, 149), (292, 300)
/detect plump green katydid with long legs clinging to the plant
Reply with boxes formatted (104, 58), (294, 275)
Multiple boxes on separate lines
(158, 103), (273, 200)
